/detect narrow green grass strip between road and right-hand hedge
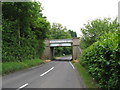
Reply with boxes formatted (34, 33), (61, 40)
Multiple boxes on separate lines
(73, 63), (98, 88)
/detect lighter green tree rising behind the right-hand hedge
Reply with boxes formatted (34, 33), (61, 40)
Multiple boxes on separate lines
(80, 18), (118, 49)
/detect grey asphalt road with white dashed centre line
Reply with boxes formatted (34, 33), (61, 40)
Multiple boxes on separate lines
(2, 57), (84, 90)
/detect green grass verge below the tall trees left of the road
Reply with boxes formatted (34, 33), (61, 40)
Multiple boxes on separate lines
(2, 59), (43, 75)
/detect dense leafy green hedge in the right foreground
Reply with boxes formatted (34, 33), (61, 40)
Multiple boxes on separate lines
(80, 30), (120, 89)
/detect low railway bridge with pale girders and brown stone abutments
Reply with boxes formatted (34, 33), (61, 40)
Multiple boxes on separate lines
(42, 38), (81, 60)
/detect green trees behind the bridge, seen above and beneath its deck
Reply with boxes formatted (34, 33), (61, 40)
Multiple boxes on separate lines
(49, 23), (72, 56)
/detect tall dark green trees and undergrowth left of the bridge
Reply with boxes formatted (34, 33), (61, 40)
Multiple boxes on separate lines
(2, 2), (50, 62)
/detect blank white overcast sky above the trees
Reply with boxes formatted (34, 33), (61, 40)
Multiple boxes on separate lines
(36, 0), (120, 37)
